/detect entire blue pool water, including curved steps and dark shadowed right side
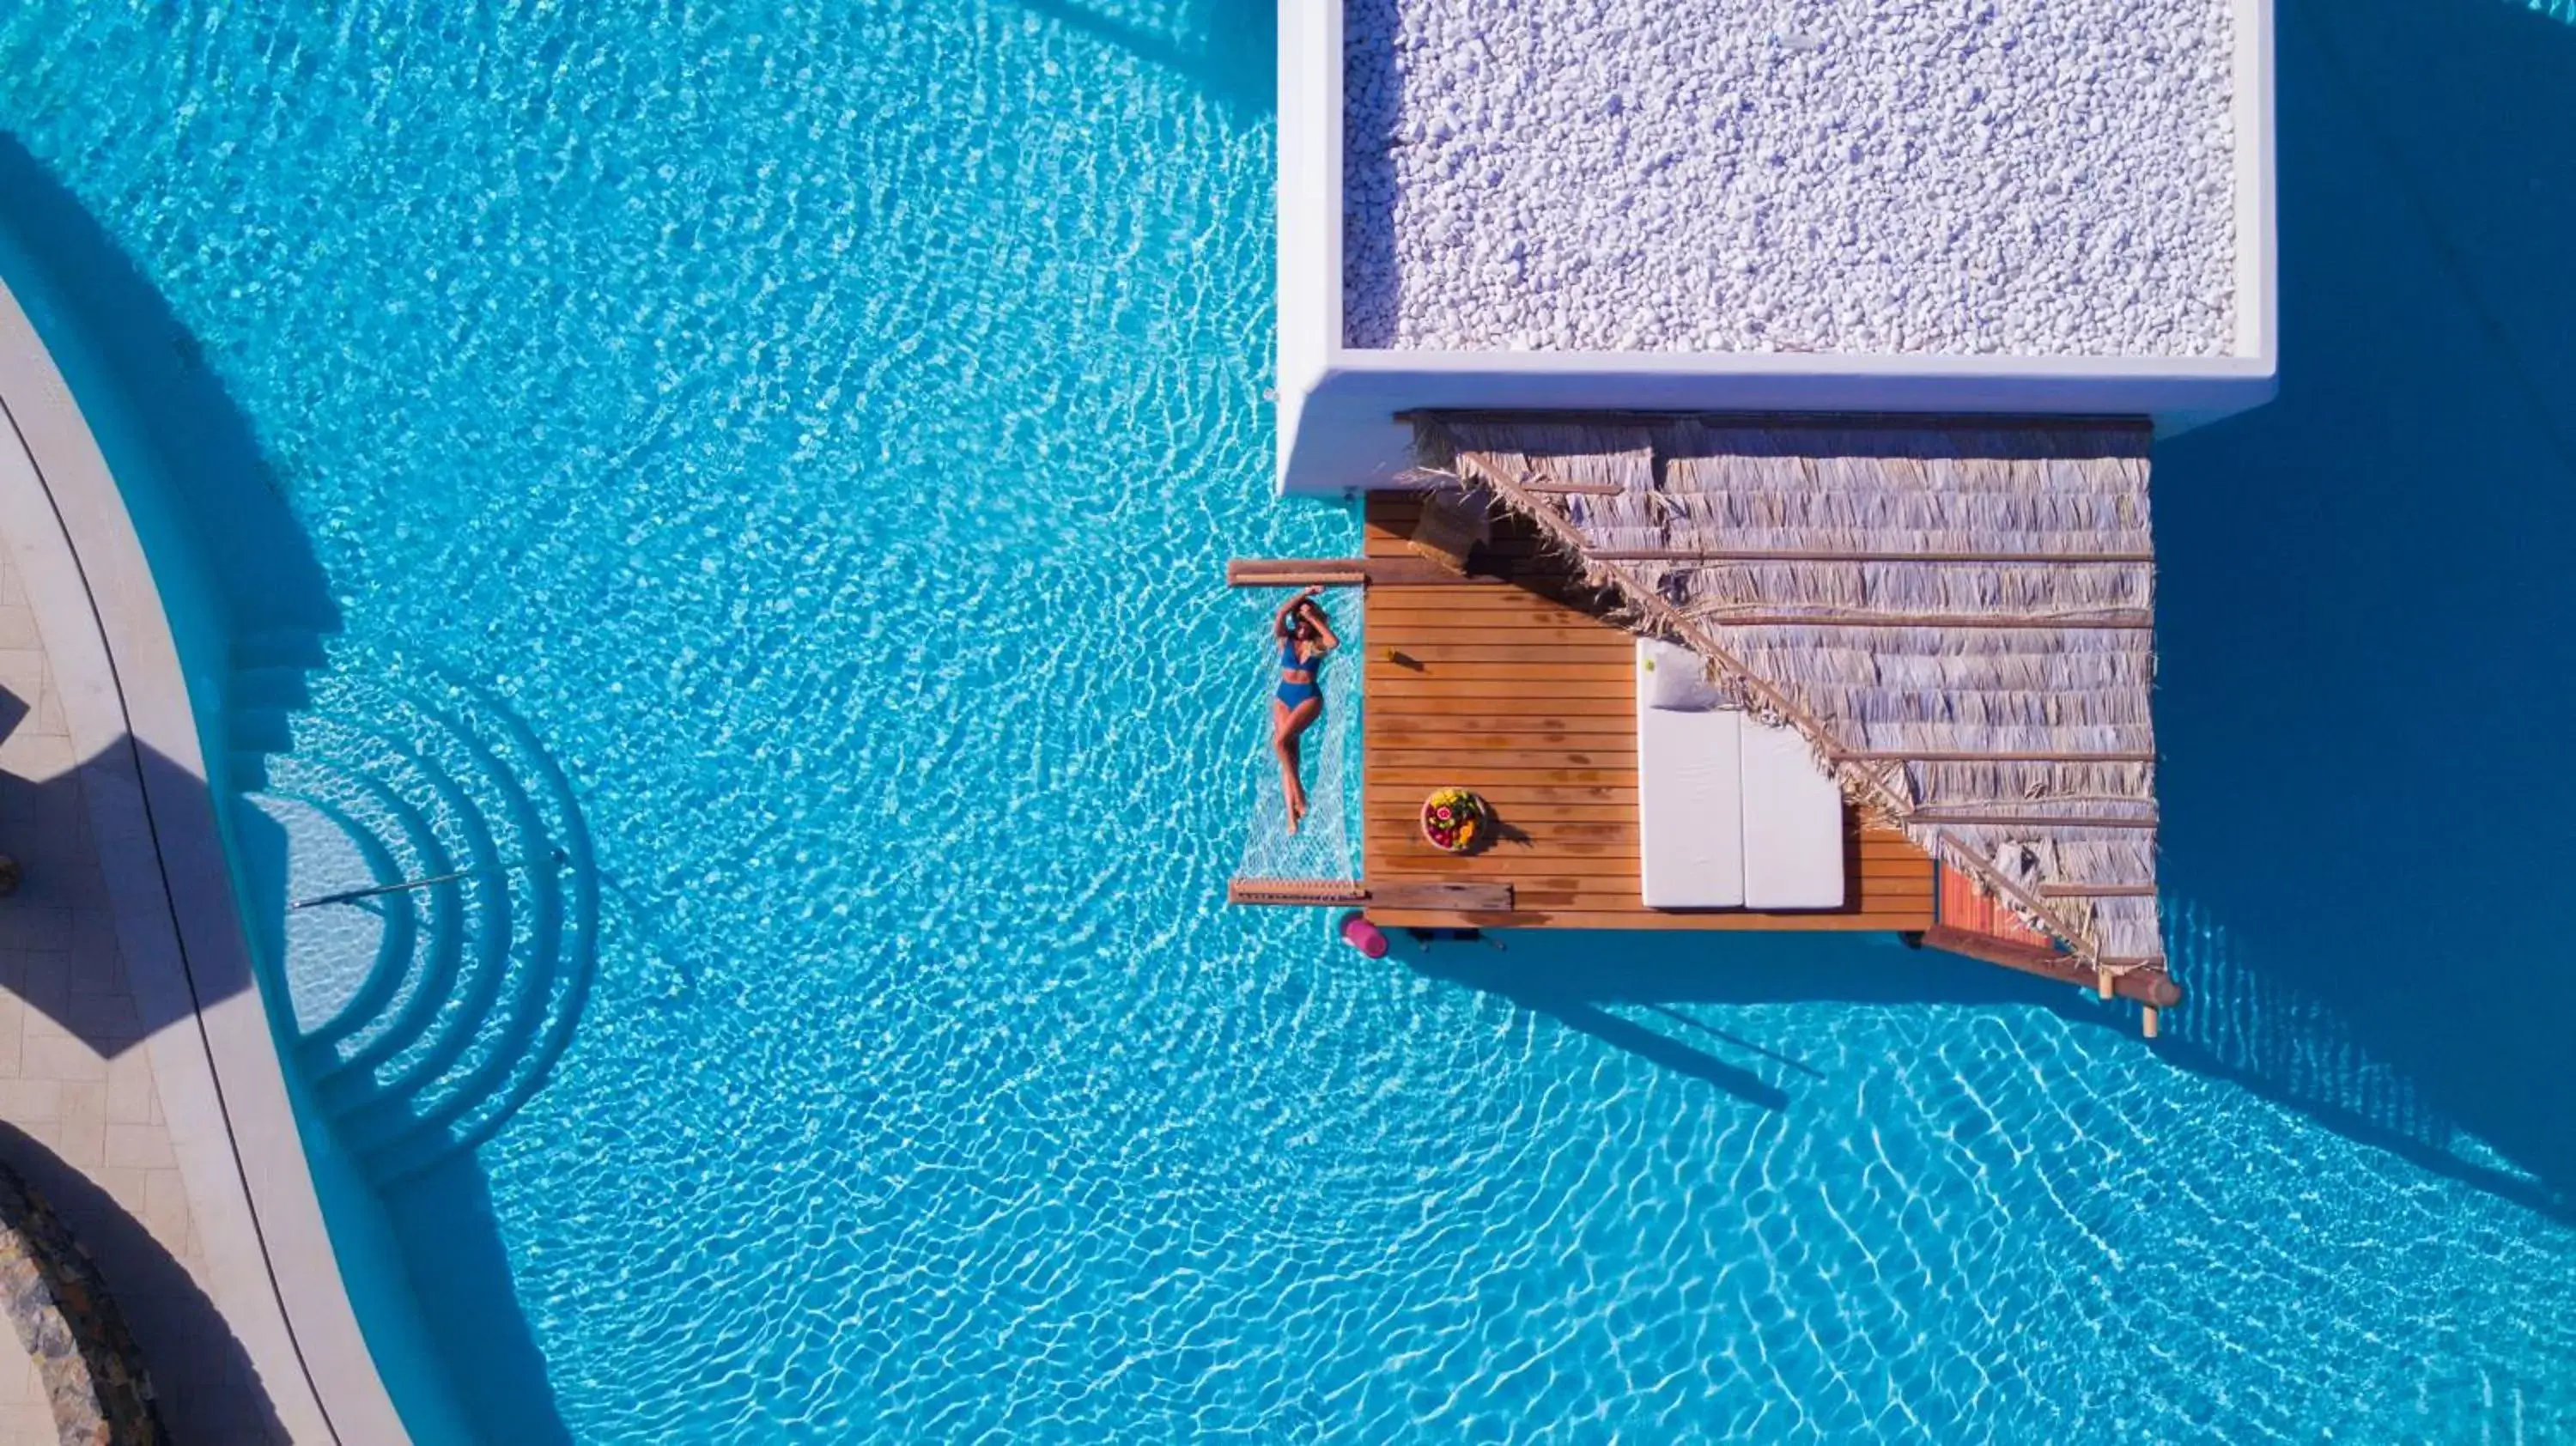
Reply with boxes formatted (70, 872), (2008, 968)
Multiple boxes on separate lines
(0, 0), (2576, 1443)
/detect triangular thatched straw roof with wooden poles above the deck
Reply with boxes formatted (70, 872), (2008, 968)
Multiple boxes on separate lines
(1414, 412), (2164, 969)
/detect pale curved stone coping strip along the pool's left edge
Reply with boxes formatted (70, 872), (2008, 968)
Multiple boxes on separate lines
(0, 270), (410, 1443)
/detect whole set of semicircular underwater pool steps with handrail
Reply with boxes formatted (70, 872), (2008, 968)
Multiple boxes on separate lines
(232, 644), (598, 1183)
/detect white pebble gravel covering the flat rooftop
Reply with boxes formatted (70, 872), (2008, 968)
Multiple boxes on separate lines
(1342, 0), (2236, 355)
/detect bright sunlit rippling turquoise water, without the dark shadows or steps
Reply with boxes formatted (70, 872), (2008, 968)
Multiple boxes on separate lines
(0, 0), (2576, 1443)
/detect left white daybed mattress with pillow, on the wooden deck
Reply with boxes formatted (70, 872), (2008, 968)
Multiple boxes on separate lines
(1636, 636), (1744, 910)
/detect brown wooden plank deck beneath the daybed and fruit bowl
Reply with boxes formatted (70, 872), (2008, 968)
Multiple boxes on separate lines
(1363, 492), (1932, 931)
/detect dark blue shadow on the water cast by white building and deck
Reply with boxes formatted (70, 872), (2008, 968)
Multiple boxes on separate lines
(1381, 0), (2576, 1222)
